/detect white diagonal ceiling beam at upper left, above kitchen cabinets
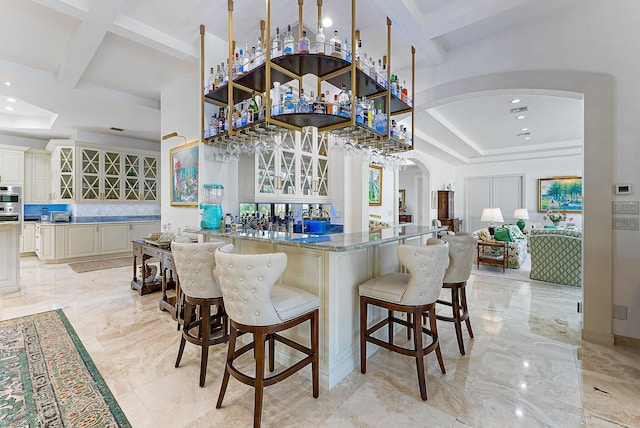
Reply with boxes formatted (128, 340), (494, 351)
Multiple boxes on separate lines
(58, 0), (126, 88)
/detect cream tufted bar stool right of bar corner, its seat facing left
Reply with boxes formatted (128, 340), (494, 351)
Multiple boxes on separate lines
(359, 239), (449, 400)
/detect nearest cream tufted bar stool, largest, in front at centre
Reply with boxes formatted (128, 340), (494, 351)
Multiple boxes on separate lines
(216, 244), (320, 427)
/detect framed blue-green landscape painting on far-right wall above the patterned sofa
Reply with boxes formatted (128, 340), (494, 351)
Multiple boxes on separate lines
(538, 177), (582, 213)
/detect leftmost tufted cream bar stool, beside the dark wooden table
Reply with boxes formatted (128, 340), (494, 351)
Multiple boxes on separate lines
(171, 241), (229, 386)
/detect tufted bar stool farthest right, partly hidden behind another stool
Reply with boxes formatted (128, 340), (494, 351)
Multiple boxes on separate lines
(437, 233), (476, 355)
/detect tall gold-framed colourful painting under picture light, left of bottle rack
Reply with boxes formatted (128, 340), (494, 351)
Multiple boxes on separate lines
(169, 141), (198, 207)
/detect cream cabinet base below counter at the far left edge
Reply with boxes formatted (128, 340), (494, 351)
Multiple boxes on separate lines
(0, 221), (20, 293)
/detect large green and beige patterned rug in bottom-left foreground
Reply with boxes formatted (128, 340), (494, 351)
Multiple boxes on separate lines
(0, 309), (131, 427)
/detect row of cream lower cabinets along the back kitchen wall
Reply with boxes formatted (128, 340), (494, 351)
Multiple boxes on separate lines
(35, 221), (160, 263)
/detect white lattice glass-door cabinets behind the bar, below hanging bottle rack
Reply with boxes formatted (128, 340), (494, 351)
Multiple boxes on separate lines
(239, 127), (330, 202)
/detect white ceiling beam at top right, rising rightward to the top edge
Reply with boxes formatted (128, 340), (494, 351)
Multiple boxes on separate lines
(424, 0), (533, 39)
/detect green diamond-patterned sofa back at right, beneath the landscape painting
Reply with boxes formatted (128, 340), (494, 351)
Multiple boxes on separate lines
(529, 229), (582, 287)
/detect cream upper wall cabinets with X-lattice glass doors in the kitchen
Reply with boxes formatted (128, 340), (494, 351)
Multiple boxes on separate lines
(47, 140), (159, 203)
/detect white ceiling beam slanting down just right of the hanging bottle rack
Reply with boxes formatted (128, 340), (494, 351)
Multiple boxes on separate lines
(373, 0), (445, 65)
